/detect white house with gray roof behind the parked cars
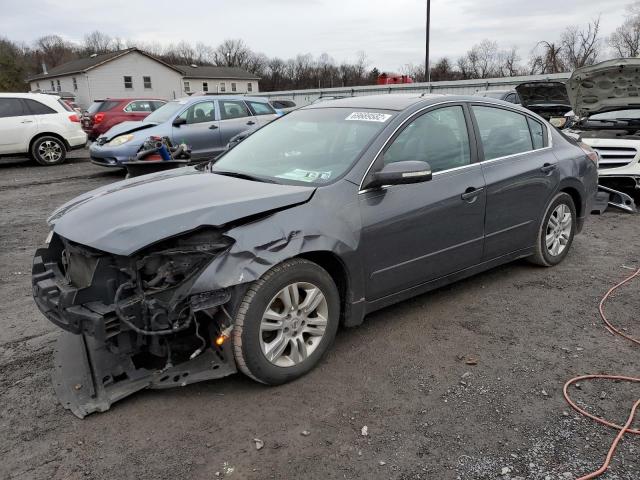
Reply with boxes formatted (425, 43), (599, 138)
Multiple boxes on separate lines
(27, 48), (259, 108)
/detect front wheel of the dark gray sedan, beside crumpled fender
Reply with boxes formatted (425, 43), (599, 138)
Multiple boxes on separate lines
(233, 259), (340, 385)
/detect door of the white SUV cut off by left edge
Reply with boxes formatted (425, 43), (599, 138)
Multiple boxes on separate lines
(0, 97), (38, 154)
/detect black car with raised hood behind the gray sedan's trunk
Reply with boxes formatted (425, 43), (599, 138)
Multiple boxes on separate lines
(516, 81), (571, 121)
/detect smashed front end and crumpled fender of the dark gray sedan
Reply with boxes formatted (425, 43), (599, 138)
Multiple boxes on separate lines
(32, 180), (364, 417)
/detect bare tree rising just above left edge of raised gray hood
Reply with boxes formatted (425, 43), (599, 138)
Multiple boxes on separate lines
(560, 18), (602, 70)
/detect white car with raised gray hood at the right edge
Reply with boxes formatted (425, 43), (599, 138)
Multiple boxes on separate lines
(563, 58), (640, 193)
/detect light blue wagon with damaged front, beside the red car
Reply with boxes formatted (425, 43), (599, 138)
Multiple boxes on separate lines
(89, 96), (280, 167)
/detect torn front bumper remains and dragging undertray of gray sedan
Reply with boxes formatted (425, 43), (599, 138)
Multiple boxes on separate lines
(32, 242), (237, 418)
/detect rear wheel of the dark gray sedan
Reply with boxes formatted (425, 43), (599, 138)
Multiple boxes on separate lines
(530, 192), (577, 267)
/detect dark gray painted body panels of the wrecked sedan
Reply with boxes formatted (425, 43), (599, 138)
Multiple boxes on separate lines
(54, 95), (597, 314)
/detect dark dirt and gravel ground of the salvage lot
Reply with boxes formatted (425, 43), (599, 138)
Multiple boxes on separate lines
(0, 159), (640, 480)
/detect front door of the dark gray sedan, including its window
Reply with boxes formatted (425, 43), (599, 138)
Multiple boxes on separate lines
(359, 104), (485, 300)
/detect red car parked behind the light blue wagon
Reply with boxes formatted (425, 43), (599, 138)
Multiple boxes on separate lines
(81, 98), (167, 140)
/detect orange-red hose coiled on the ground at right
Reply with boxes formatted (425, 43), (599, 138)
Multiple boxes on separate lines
(562, 269), (640, 480)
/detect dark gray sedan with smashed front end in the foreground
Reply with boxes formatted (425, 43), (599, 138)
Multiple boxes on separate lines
(33, 95), (598, 417)
